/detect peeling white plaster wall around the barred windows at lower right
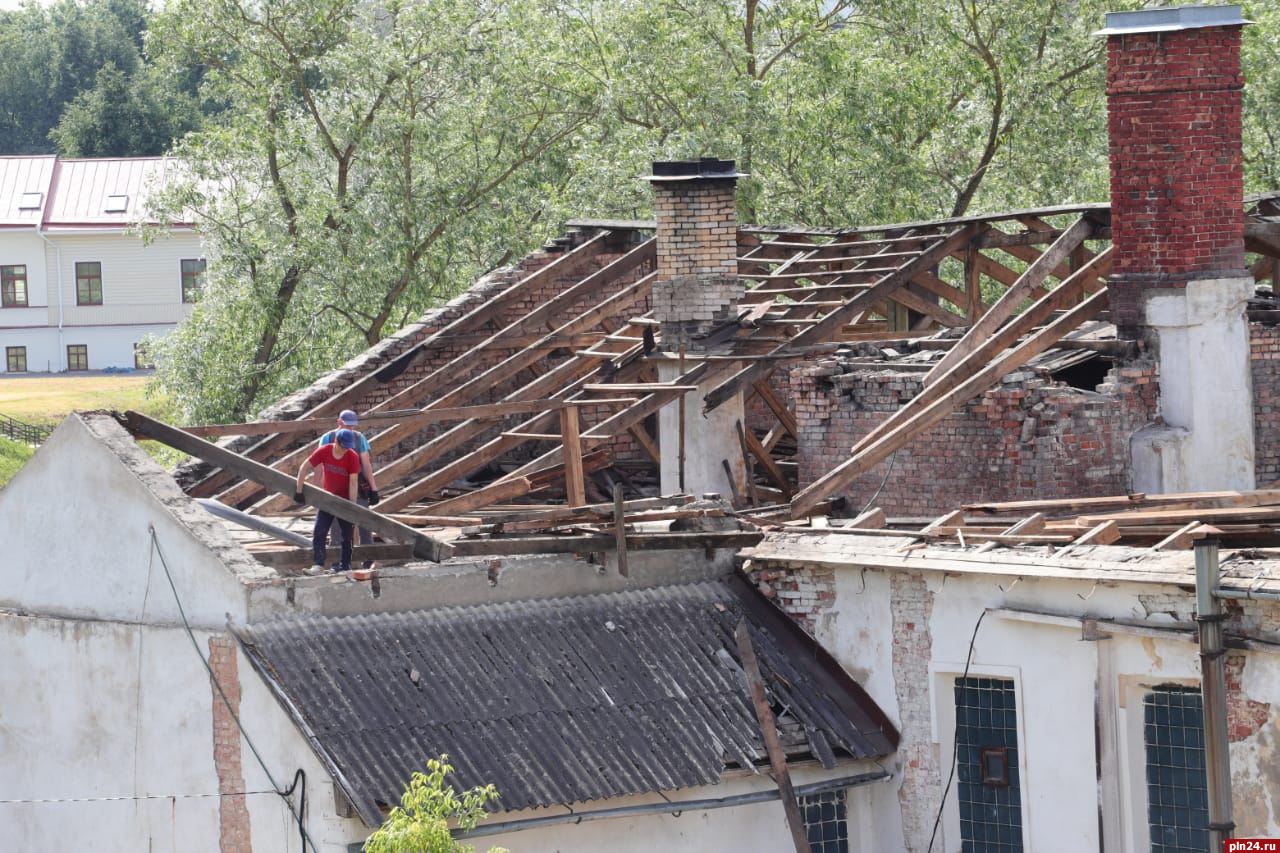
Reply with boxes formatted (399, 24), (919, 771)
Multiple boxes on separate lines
(818, 558), (1280, 852)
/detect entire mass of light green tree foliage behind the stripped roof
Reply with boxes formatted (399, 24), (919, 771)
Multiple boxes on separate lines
(132, 0), (1280, 420)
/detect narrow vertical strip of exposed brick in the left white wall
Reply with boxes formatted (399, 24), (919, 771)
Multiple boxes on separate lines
(209, 637), (253, 853)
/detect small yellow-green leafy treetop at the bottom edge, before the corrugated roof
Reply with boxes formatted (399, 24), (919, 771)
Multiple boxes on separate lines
(365, 756), (506, 853)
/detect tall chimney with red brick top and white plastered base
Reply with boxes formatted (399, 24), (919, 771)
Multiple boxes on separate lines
(1101, 5), (1254, 493)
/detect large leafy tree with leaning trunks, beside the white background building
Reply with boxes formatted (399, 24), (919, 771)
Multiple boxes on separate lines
(148, 0), (591, 419)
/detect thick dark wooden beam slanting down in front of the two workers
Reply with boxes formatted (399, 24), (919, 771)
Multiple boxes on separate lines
(120, 411), (451, 562)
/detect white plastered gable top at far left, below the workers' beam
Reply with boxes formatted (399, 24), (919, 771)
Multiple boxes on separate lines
(0, 415), (257, 628)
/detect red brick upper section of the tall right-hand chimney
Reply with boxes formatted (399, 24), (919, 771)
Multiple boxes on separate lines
(1107, 19), (1244, 337)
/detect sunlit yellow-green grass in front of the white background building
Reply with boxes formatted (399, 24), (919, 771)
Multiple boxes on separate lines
(0, 373), (184, 488)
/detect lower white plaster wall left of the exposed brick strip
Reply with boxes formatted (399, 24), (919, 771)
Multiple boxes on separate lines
(0, 615), (218, 853)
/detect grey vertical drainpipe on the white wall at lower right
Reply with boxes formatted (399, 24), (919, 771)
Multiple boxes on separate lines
(1193, 525), (1235, 850)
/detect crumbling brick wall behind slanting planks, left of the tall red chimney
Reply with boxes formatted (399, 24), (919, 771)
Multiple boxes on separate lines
(790, 360), (1157, 517)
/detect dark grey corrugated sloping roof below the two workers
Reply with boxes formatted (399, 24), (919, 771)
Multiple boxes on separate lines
(239, 576), (897, 826)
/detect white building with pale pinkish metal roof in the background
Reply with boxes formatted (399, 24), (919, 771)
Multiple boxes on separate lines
(0, 156), (205, 373)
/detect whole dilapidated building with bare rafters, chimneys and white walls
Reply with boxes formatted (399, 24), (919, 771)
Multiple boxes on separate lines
(0, 6), (1280, 853)
